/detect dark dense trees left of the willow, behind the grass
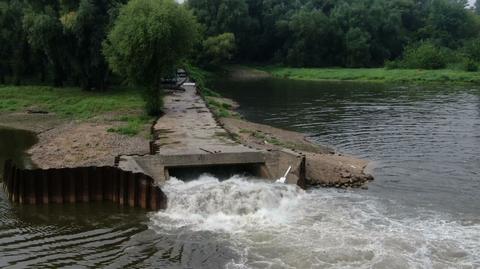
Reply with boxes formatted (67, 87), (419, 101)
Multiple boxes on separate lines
(0, 0), (127, 90)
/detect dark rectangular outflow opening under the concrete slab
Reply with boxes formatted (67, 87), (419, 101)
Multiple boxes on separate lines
(166, 164), (263, 181)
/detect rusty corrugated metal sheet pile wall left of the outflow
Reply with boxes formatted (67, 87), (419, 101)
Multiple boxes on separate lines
(3, 161), (167, 210)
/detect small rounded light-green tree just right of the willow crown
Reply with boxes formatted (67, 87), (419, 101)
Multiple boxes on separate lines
(203, 33), (235, 65)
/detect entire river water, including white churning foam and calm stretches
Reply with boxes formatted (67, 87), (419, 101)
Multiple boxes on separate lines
(0, 76), (480, 268)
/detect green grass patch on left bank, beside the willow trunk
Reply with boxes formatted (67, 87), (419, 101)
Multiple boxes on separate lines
(0, 85), (152, 136)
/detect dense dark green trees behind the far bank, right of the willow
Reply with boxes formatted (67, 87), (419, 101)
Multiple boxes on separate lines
(188, 0), (480, 68)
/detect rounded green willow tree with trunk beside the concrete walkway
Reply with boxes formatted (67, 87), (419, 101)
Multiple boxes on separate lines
(104, 0), (199, 115)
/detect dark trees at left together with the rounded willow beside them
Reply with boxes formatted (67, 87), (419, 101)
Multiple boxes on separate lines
(0, 0), (200, 115)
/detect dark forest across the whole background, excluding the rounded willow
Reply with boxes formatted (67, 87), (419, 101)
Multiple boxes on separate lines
(0, 0), (480, 90)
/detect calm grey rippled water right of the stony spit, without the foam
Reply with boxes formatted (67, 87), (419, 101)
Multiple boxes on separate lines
(214, 79), (480, 216)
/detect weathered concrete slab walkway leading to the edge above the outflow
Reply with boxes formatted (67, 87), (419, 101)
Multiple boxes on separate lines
(119, 80), (284, 184)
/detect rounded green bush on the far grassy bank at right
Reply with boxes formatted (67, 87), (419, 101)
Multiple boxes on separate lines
(402, 42), (455, 69)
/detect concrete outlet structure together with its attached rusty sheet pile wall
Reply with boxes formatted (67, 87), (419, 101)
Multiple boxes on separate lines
(3, 78), (306, 210)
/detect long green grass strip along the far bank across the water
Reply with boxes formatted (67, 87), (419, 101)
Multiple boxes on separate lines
(256, 66), (480, 83)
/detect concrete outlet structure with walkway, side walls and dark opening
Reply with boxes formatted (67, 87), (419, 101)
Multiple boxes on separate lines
(118, 83), (305, 185)
